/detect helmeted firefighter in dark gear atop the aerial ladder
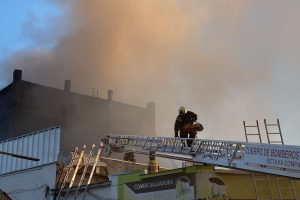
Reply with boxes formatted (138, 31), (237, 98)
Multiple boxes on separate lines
(174, 106), (203, 147)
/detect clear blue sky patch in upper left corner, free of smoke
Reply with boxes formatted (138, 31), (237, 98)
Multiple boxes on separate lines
(0, 0), (61, 58)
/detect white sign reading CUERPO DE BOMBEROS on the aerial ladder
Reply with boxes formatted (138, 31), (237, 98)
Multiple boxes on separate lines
(244, 144), (300, 170)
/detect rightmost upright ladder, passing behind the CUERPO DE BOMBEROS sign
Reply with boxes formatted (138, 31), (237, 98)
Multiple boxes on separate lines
(264, 119), (297, 200)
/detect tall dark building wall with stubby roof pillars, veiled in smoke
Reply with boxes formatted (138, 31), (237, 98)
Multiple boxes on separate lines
(0, 70), (155, 151)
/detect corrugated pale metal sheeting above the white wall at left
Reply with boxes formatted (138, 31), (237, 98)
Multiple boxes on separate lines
(0, 127), (61, 174)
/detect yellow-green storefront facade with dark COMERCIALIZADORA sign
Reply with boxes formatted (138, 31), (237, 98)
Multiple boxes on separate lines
(117, 166), (300, 200)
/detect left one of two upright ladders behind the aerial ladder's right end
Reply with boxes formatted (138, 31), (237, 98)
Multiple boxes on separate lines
(243, 120), (273, 200)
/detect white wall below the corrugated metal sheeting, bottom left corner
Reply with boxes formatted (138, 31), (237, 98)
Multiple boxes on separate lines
(0, 163), (56, 200)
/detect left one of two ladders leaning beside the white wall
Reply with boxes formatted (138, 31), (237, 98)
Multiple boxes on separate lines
(56, 145), (86, 200)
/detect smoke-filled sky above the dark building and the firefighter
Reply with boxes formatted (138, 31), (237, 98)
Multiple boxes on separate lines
(0, 0), (300, 145)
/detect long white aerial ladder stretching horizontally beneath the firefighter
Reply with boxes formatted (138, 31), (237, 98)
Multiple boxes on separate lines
(103, 135), (300, 178)
